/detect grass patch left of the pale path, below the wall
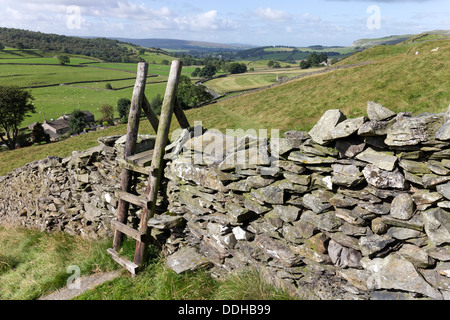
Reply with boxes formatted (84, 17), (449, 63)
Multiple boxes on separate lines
(0, 227), (117, 300)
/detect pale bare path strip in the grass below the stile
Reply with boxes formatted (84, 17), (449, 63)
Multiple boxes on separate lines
(38, 271), (120, 300)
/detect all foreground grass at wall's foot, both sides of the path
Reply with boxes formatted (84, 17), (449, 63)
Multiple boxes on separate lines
(0, 227), (294, 300)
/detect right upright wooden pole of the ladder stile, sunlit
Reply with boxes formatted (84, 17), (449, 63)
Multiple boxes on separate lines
(134, 60), (183, 265)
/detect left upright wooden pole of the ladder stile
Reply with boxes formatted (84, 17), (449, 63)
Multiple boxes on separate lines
(113, 62), (148, 251)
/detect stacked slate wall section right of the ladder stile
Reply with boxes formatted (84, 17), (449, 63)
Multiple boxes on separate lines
(165, 102), (450, 299)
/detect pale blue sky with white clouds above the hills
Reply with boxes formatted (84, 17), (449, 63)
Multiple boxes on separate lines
(0, 0), (450, 46)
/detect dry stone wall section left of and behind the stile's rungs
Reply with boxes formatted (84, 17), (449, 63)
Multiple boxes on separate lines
(0, 136), (160, 239)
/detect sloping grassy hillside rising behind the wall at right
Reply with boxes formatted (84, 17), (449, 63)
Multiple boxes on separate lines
(188, 39), (450, 131)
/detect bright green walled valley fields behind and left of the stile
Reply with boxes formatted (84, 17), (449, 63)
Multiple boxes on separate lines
(0, 50), (199, 127)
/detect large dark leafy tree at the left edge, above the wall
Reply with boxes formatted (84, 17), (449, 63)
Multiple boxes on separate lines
(0, 86), (36, 150)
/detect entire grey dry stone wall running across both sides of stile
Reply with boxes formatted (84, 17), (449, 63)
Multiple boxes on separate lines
(0, 102), (450, 300)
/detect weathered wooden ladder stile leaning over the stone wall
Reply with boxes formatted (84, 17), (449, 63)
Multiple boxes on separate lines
(107, 60), (190, 275)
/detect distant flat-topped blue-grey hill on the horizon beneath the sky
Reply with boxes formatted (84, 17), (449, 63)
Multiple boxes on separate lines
(114, 38), (256, 51)
